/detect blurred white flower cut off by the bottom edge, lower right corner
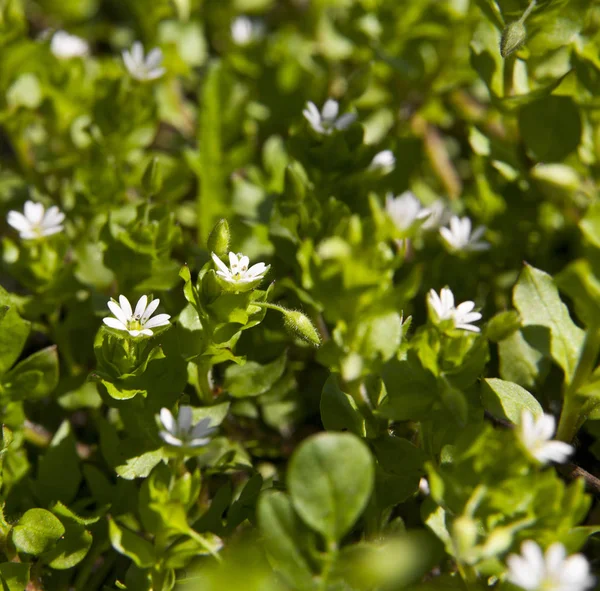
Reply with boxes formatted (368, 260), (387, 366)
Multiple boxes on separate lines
(506, 540), (595, 591)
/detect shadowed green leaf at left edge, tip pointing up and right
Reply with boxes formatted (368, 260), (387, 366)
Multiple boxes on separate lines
(3, 345), (58, 400)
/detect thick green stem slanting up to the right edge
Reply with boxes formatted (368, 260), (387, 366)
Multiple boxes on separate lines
(556, 326), (600, 443)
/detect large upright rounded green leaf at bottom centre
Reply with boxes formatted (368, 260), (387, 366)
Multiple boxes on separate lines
(287, 433), (374, 542)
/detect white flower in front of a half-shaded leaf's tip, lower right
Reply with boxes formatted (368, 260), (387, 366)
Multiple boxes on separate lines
(516, 409), (574, 464)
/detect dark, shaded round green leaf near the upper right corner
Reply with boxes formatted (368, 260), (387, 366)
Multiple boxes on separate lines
(519, 95), (582, 162)
